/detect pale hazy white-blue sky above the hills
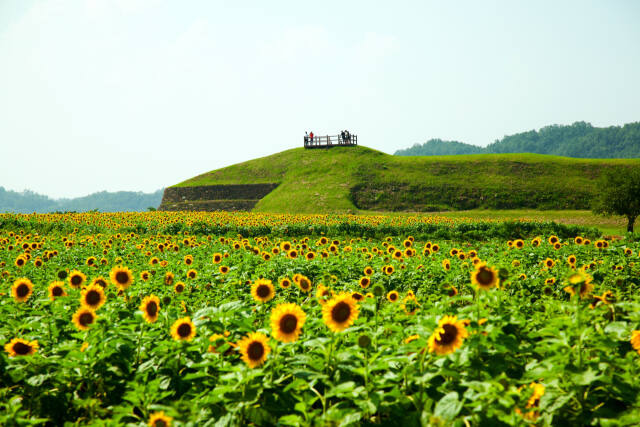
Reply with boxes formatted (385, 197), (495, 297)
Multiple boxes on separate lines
(0, 0), (640, 197)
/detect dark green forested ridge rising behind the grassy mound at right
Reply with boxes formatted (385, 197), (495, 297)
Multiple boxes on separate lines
(395, 122), (640, 159)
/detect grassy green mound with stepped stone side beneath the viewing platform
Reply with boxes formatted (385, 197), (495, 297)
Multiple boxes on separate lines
(161, 146), (640, 213)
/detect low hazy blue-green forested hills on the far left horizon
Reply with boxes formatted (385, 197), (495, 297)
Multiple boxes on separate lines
(0, 187), (164, 213)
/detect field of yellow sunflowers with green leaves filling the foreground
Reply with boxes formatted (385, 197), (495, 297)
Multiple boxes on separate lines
(0, 212), (640, 426)
